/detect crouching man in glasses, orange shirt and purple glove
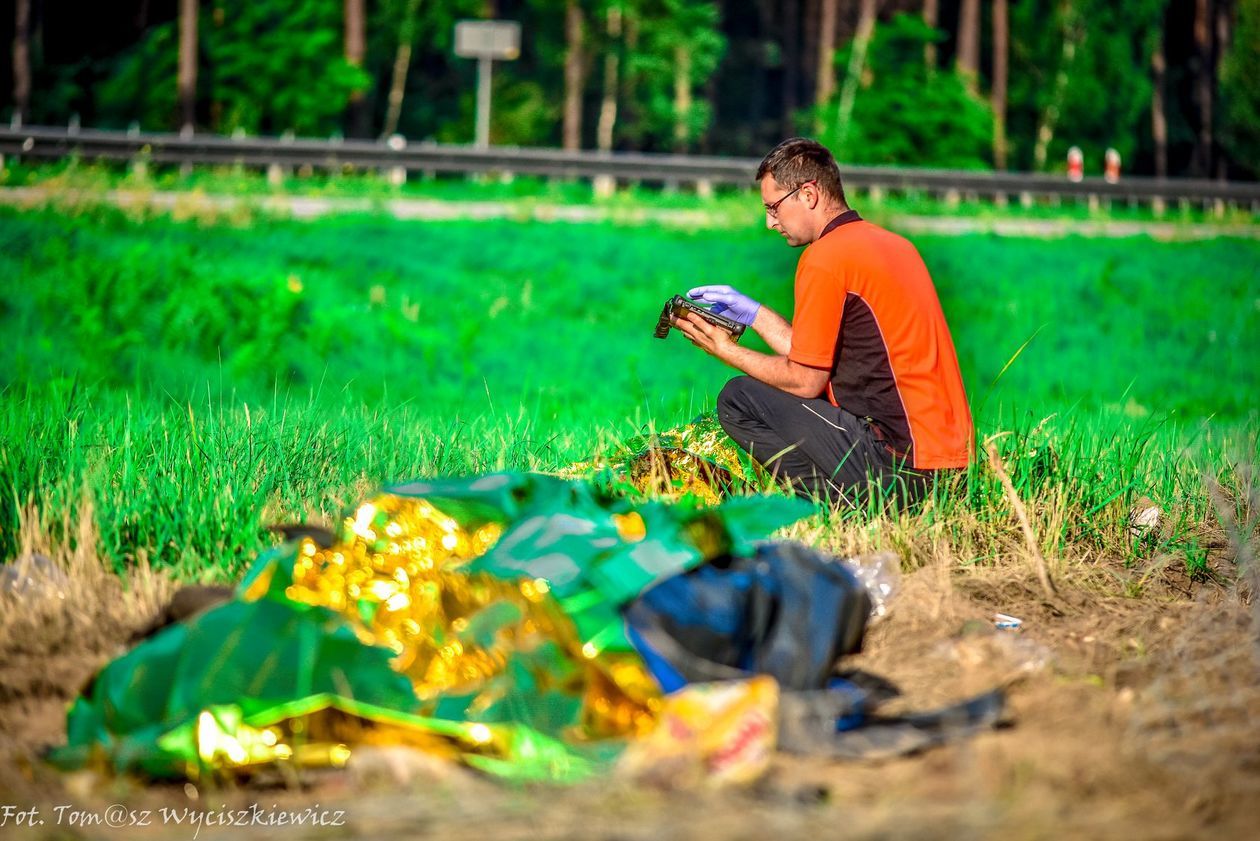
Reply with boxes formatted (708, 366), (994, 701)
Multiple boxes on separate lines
(677, 137), (974, 504)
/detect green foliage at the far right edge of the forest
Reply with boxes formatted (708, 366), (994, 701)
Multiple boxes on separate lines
(1221, 0), (1260, 177)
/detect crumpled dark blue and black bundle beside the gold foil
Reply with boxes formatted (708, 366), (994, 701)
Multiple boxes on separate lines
(625, 542), (1005, 759)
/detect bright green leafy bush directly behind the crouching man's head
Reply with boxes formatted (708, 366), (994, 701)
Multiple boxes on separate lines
(801, 14), (993, 169)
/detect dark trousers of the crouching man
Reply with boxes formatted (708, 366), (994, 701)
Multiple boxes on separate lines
(717, 377), (932, 506)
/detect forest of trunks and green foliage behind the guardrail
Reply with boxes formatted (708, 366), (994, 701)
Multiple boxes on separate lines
(0, 0), (1260, 179)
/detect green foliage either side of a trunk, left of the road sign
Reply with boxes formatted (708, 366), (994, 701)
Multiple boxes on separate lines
(101, 0), (369, 136)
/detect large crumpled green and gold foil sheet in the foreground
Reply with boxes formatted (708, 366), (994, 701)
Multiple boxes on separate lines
(50, 473), (811, 780)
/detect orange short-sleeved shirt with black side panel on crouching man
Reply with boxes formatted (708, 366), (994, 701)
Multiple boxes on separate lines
(788, 211), (974, 470)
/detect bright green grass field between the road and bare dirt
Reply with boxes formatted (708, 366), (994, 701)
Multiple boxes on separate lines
(0, 208), (1260, 580)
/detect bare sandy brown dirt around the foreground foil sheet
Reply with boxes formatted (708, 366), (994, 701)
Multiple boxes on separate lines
(0, 549), (1260, 841)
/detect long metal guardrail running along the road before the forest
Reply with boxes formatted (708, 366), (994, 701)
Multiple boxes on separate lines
(0, 126), (1260, 212)
